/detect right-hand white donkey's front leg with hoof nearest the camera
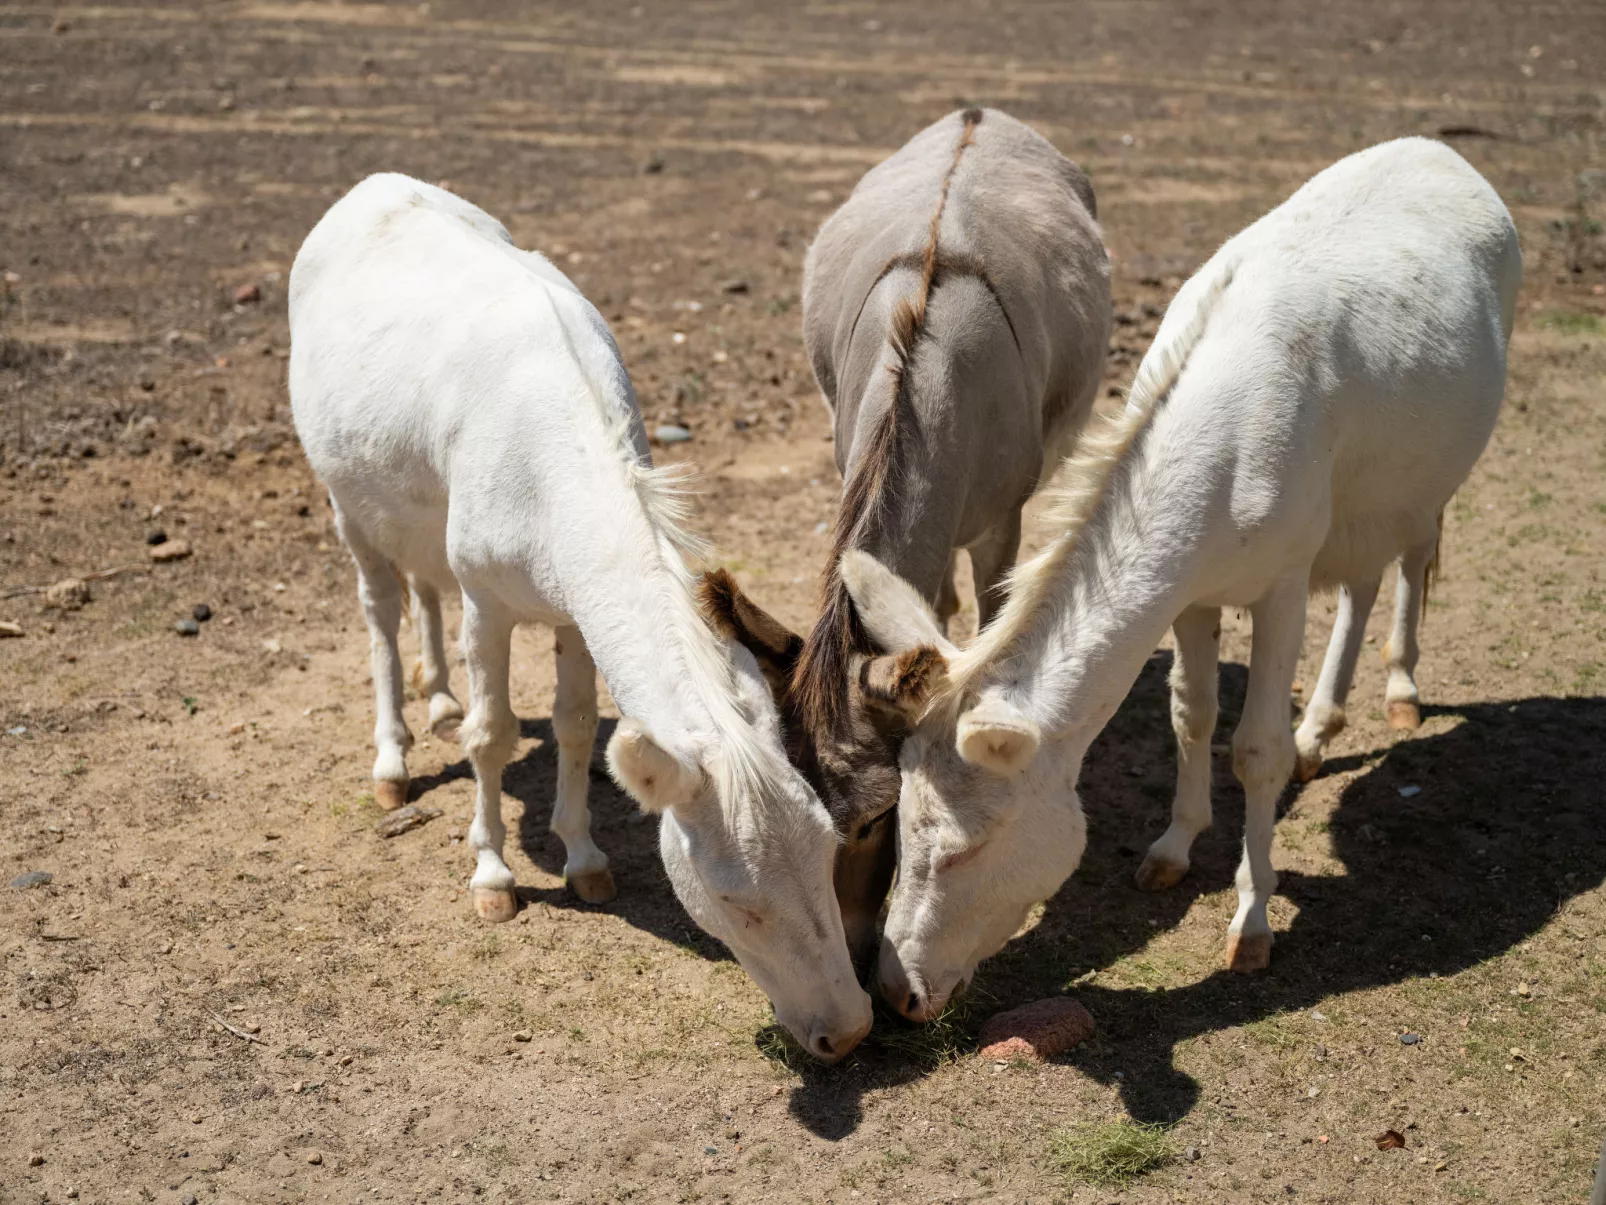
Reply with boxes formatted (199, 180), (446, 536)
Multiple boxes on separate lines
(1227, 578), (1306, 970)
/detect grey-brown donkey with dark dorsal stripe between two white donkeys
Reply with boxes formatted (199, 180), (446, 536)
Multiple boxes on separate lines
(702, 109), (1110, 950)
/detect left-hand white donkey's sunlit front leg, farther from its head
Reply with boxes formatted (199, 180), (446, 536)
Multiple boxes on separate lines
(458, 593), (519, 922)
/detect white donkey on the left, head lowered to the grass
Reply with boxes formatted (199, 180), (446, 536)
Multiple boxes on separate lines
(291, 175), (870, 1060)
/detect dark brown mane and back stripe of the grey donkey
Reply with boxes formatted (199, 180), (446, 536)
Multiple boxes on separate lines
(789, 109), (982, 737)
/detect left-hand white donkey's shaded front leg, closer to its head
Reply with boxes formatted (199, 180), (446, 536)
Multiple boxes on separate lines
(552, 628), (617, 903)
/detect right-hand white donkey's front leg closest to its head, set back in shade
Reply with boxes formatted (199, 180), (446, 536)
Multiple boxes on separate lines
(1137, 607), (1221, 892)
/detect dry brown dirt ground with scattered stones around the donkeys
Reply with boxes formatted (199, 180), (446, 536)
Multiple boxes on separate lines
(0, 0), (1606, 1205)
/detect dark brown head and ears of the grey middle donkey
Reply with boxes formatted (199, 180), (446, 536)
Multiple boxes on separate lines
(699, 569), (946, 961)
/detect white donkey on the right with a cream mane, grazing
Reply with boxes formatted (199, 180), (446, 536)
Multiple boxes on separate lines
(843, 138), (1522, 1019)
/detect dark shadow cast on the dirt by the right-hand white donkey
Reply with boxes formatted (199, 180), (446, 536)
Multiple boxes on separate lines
(777, 652), (1606, 1138)
